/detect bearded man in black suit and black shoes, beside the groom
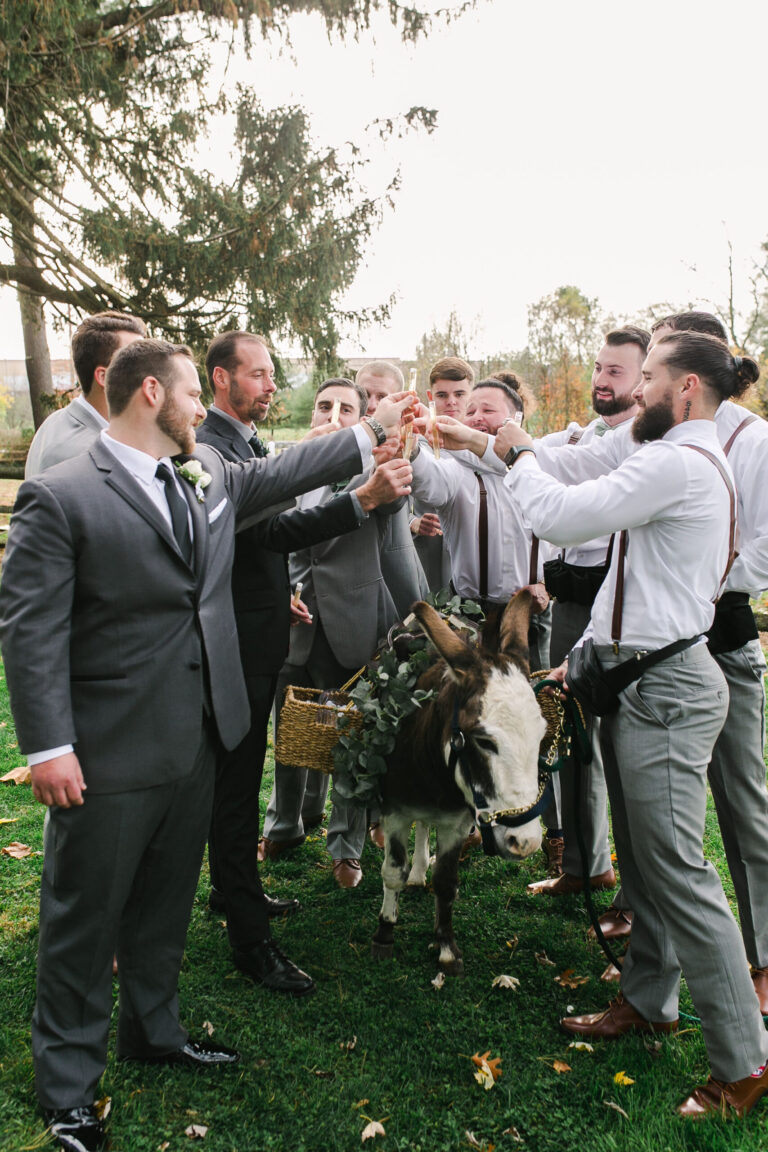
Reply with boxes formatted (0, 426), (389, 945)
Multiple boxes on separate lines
(197, 331), (375, 996)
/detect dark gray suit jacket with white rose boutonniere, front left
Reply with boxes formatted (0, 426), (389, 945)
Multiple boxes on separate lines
(0, 430), (362, 793)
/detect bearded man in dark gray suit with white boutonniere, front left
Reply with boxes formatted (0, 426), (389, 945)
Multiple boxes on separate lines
(0, 340), (408, 1150)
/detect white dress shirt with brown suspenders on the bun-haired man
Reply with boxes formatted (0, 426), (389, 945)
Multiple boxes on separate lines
(504, 420), (730, 651)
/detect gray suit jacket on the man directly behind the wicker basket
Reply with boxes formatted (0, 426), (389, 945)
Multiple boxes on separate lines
(288, 473), (403, 668)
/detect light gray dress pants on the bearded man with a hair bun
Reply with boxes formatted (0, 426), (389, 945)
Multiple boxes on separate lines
(598, 644), (768, 1082)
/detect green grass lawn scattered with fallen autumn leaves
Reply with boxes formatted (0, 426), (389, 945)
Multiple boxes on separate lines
(0, 683), (768, 1152)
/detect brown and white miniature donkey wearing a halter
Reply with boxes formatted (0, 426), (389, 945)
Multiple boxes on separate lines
(371, 590), (546, 976)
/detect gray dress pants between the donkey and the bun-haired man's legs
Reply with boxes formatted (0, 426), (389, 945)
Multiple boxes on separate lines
(550, 600), (610, 876)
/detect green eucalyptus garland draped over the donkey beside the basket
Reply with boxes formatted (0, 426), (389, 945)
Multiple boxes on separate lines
(333, 589), (484, 808)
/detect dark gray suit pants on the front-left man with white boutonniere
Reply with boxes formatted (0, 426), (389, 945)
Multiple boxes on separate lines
(32, 721), (214, 1109)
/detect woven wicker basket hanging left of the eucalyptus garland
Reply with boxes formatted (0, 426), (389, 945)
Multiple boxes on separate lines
(275, 677), (363, 772)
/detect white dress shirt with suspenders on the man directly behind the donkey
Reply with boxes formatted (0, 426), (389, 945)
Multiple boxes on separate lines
(412, 437), (553, 602)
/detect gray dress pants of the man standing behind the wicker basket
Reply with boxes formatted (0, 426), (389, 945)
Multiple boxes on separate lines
(264, 620), (367, 861)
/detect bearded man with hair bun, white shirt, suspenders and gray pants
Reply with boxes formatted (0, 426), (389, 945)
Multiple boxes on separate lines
(495, 332), (768, 1117)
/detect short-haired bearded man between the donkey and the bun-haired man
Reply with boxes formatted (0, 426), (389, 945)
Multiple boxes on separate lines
(529, 325), (651, 898)
